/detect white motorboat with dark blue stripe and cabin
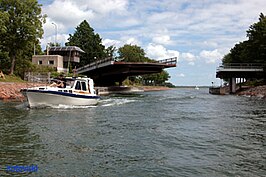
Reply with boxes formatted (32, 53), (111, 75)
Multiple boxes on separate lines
(21, 78), (100, 108)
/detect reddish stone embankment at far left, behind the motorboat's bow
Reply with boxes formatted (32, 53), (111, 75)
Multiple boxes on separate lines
(0, 82), (44, 101)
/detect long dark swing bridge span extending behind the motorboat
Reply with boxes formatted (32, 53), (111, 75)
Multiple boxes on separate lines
(76, 57), (177, 86)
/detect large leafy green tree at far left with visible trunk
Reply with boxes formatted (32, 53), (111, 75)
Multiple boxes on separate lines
(0, 0), (46, 74)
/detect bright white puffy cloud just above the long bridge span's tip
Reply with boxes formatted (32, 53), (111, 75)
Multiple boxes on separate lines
(146, 43), (179, 59)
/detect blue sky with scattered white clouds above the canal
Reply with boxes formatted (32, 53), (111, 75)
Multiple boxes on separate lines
(39, 0), (266, 86)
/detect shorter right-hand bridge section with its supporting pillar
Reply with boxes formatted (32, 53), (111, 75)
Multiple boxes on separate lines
(216, 63), (266, 93)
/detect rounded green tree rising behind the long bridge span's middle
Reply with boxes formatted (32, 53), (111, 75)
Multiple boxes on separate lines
(118, 44), (151, 62)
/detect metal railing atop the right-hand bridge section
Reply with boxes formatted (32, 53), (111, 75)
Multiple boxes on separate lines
(217, 63), (266, 71)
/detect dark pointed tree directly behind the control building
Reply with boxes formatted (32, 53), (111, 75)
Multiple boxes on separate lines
(66, 20), (107, 66)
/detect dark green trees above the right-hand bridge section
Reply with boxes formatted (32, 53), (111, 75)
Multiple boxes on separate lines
(223, 13), (266, 63)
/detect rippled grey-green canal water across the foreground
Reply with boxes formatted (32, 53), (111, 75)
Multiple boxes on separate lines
(0, 89), (266, 177)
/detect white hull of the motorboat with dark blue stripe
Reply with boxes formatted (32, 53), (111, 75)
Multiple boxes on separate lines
(25, 90), (99, 108)
